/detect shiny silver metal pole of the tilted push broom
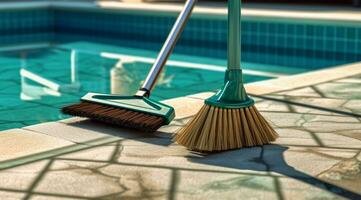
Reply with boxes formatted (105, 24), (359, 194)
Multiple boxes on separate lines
(136, 0), (197, 96)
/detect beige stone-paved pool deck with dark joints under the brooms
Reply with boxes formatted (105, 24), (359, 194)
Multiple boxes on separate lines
(0, 63), (361, 200)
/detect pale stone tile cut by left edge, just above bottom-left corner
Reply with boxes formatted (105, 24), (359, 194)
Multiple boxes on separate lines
(0, 161), (48, 191)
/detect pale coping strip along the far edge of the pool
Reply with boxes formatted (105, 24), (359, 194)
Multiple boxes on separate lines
(0, 1), (361, 25)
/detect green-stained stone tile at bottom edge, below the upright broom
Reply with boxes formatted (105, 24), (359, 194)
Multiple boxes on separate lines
(176, 171), (278, 200)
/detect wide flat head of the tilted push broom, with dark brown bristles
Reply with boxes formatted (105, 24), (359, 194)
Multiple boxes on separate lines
(62, 93), (175, 132)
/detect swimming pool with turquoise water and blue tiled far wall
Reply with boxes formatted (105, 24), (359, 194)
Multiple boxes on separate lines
(0, 3), (361, 130)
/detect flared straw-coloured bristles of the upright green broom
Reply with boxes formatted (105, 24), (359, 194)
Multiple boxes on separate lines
(175, 105), (278, 152)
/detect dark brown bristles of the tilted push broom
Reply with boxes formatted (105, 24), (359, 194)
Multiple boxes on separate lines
(62, 102), (165, 132)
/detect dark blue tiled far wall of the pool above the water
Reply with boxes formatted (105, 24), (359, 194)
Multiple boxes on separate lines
(0, 8), (361, 68)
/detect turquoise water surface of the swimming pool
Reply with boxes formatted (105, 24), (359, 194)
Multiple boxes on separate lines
(0, 42), (304, 130)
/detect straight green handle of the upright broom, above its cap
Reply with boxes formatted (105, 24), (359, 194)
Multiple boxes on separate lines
(228, 0), (241, 70)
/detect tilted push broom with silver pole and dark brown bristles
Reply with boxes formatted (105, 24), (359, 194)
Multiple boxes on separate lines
(62, 0), (196, 132)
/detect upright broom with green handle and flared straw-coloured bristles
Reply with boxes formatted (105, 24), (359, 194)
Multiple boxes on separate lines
(175, 0), (277, 152)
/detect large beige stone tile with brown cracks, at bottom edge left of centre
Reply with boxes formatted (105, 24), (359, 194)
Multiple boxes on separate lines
(35, 162), (171, 199)
